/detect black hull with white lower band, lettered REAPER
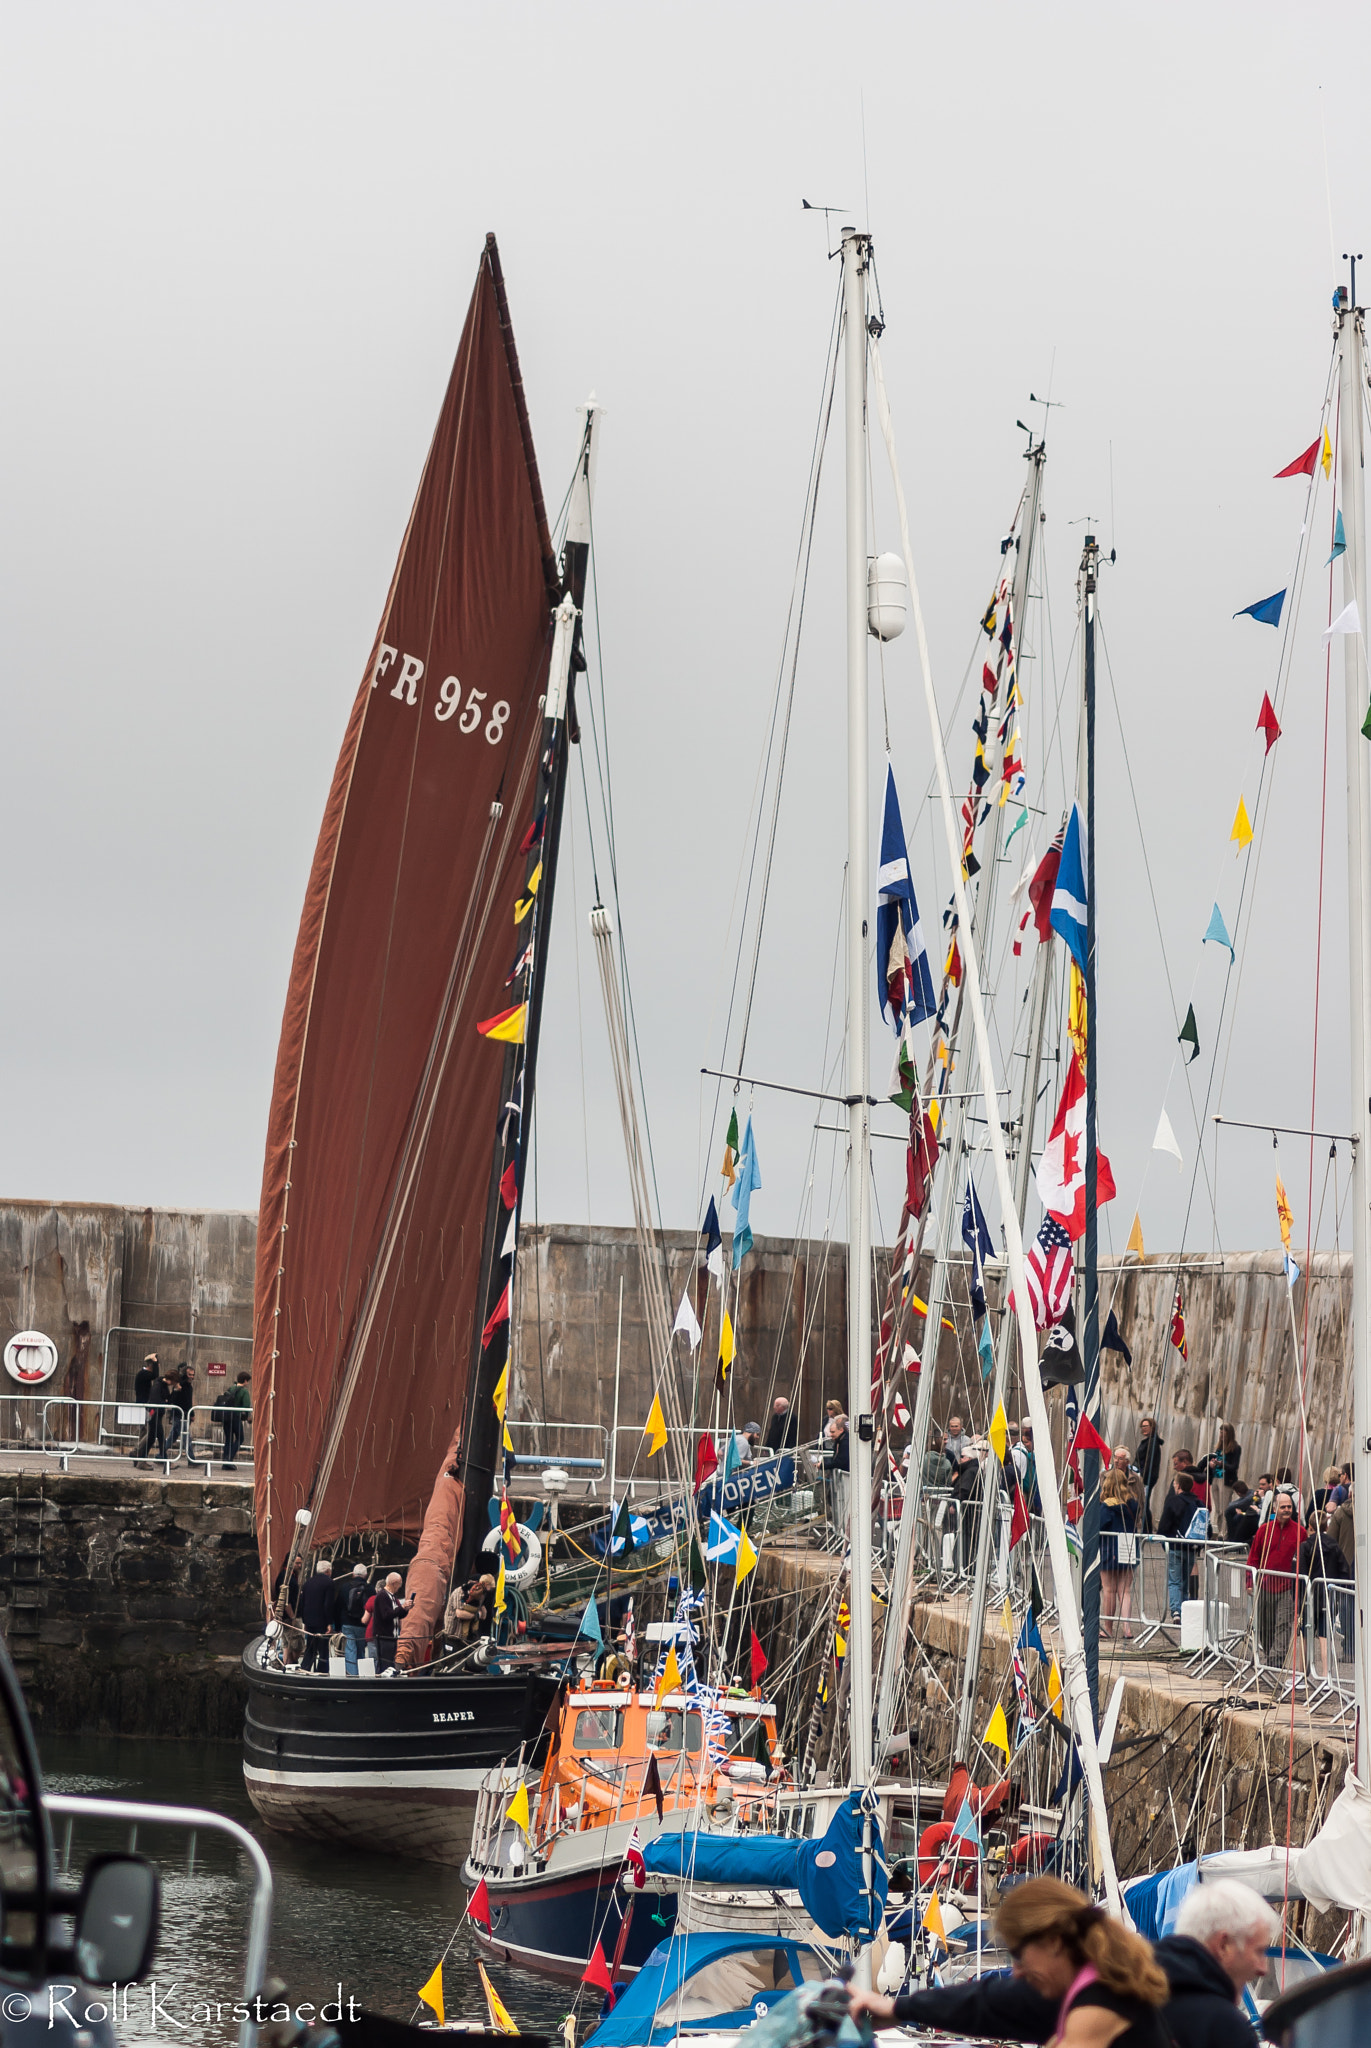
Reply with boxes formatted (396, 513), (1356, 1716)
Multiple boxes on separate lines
(244, 1638), (557, 1864)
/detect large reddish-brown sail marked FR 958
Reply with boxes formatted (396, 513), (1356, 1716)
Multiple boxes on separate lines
(252, 238), (557, 1597)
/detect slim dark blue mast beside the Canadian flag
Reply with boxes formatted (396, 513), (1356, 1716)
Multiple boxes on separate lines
(1080, 532), (1100, 1729)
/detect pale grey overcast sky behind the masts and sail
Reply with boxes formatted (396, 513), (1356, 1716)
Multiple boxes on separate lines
(0, 0), (1371, 1249)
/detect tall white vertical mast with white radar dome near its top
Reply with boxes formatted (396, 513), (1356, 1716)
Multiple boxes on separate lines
(842, 227), (875, 1985)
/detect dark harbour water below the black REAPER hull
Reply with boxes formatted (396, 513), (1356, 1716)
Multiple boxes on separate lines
(39, 1737), (573, 2048)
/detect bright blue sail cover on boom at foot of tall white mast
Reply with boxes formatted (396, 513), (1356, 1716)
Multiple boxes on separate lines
(643, 1794), (889, 1942)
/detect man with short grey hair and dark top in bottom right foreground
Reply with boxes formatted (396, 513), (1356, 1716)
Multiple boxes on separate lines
(1156, 1878), (1281, 2048)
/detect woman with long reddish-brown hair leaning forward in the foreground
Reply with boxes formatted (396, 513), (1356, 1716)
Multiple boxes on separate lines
(850, 1878), (1170, 2048)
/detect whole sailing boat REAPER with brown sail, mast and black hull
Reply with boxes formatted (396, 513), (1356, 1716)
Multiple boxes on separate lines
(244, 236), (594, 1858)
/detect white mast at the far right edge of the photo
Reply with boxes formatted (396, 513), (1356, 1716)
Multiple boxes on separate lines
(1334, 272), (1371, 1826)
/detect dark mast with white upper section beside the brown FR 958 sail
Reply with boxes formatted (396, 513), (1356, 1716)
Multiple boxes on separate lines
(455, 397), (598, 1577)
